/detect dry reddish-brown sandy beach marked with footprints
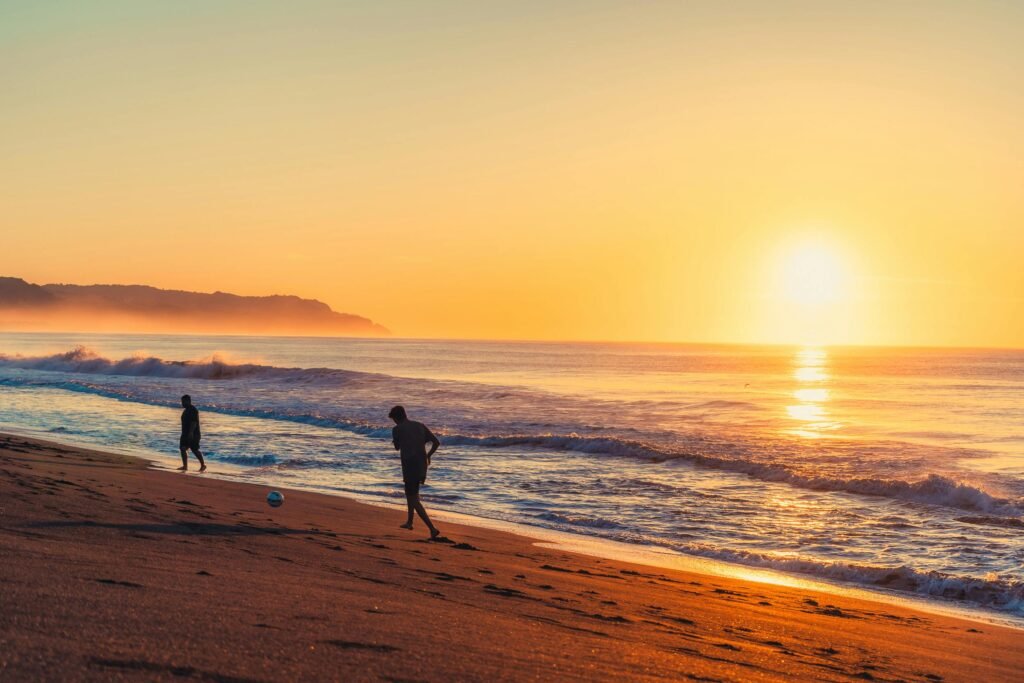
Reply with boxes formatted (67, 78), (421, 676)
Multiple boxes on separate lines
(0, 436), (1024, 681)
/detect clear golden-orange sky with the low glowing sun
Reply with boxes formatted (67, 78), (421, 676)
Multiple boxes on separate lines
(0, 0), (1024, 347)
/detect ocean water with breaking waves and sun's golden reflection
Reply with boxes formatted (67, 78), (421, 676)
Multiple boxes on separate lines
(0, 334), (1024, 617)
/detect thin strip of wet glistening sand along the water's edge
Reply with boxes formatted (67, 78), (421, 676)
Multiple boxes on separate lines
(9, 427), (1024, 631)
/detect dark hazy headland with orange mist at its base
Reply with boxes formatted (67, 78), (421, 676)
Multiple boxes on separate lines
(0, 278), (389, 336)
